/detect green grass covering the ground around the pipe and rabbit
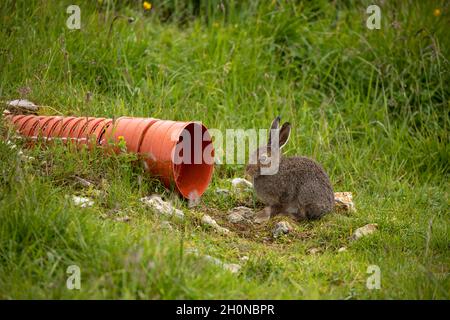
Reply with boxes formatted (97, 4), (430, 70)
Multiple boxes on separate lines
(0, 0), (450, 299)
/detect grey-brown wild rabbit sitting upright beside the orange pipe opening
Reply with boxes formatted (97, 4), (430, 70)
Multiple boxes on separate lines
(246, 117), (334, 223)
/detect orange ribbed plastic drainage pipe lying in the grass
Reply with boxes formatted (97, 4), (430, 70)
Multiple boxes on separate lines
(5, 115), (214, 199)
